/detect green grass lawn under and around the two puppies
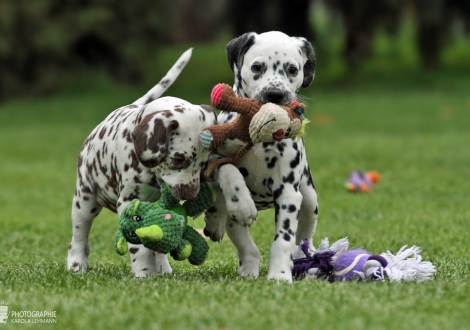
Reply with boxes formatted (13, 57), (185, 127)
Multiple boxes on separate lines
(0, 45), (470, 330)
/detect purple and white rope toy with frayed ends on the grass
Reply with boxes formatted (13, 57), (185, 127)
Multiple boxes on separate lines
(292, 238), (436, 282)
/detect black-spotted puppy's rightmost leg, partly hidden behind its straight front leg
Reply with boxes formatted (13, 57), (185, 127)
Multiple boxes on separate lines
(296, 165), (318, 248)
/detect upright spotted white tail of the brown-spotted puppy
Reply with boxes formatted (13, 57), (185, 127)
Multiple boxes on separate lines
(132, 48), (193, 105)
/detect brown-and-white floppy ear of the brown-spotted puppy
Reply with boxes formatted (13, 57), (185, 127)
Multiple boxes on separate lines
(132, 111), (179, 168)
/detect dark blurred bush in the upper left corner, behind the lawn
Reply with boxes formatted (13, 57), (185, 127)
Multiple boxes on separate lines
(0, 0), (165, 99)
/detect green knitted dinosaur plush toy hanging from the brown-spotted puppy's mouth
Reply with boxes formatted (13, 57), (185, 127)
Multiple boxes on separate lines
(116, 183), (215, 266)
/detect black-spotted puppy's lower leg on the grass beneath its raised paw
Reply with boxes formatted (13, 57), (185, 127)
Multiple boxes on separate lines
(227, 219), (260, 277)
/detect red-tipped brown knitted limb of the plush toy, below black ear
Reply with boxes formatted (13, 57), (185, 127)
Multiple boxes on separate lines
(211, 84), (262, 114)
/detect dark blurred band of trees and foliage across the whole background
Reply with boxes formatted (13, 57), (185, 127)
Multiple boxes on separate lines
(0, 0), (470, 100)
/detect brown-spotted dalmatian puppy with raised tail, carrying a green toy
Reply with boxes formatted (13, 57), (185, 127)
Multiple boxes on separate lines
(67, 50), (216, 277)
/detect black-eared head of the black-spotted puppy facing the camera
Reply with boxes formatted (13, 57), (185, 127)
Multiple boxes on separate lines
(227, 31), (315, 105)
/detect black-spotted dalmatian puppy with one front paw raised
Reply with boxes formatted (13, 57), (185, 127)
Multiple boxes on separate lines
(204, 31), (318, 282)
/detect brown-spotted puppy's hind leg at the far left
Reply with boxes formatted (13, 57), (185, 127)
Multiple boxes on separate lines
(67, 187), (102, 273)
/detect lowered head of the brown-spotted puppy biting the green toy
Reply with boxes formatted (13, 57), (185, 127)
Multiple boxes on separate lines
(132, 105), (216, 200)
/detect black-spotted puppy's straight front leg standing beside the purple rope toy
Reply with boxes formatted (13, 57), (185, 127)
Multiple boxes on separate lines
(268, 184), (302, 283)
